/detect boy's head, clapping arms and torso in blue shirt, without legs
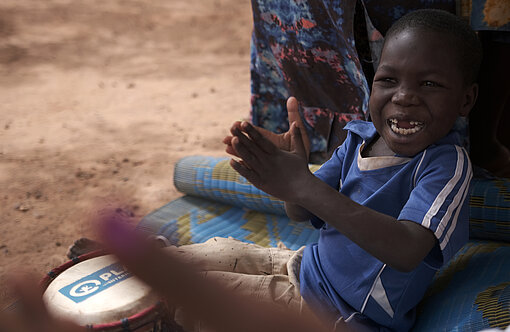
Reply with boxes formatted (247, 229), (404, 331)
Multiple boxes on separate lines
(225, 10), (481, 331)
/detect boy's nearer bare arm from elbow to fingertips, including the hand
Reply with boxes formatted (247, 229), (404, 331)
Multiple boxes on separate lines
(231, 123), (436, 271)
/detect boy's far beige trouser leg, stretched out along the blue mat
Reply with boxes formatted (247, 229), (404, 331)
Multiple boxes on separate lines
(165, 237), (295, 275)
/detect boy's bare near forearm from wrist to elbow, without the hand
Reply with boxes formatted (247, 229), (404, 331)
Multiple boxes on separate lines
(296, 175), (437, 272)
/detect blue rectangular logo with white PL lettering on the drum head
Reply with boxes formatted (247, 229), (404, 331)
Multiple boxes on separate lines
(58, 263), (131, 303)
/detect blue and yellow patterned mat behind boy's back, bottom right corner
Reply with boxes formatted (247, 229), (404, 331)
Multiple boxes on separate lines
(413, 242), (510, 332)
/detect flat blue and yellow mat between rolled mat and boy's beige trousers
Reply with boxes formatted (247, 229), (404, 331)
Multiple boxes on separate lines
(137, 196), (319, 250)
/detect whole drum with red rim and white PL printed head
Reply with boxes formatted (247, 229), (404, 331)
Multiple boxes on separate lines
(42, 251), (169, 332)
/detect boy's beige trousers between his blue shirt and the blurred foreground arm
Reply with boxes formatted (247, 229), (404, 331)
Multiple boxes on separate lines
(166, 238), (310, 331)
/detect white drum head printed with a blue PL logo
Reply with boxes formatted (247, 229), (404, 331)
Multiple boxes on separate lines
(43, 255), (159, 326)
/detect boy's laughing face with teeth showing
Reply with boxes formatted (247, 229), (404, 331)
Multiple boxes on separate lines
(369, 29), (477, 156)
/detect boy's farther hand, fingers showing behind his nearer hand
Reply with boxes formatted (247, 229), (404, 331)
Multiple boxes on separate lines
(223, 97), (310, 159)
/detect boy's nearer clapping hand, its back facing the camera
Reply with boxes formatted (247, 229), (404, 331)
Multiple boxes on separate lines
(230, 122), (312, 202)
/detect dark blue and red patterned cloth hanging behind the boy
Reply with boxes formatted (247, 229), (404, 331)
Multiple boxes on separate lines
(251, 0), (455, 163)
